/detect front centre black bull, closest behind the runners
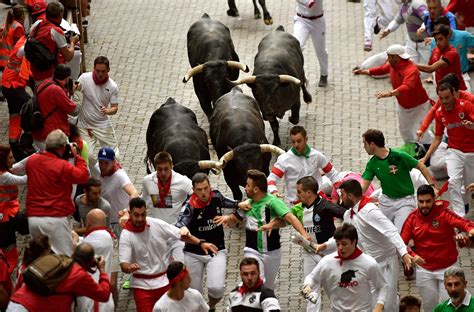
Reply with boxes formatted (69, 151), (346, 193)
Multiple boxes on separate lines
(210, 87), (284, 200)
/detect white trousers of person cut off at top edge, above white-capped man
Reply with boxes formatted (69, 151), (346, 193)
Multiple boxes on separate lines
(364, 0), (394, 43)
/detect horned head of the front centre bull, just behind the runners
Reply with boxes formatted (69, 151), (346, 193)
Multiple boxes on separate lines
(219, 144), (285, 186)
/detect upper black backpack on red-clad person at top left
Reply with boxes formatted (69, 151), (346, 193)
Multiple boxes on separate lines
(24, 22), (58, 71)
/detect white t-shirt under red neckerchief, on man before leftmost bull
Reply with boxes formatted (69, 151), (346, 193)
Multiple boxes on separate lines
(142, 171), (193, 224)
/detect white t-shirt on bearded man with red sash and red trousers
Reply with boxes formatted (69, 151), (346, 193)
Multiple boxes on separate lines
(119, 217), (181, 289)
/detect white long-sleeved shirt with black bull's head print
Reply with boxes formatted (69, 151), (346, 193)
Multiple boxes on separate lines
(304, 252), (388, 311)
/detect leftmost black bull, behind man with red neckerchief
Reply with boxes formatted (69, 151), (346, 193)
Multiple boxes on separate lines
(145, 98), (220, 179)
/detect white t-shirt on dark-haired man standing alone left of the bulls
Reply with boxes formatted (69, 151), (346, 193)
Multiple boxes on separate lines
(77, 72), (118, 129)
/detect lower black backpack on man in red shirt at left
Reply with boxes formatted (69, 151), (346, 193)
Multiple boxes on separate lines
(20, 82), (58, 132)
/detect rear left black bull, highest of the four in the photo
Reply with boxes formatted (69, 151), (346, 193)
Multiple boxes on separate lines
(183, 14), (249, 118)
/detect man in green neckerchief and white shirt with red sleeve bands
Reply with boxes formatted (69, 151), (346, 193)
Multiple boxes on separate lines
(268, 126), (339, 205)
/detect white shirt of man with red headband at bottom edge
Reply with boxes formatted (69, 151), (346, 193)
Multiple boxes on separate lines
(153, 288), (209, 312)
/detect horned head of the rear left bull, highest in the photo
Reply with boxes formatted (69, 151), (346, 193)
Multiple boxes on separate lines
(183, 61), (249, 103)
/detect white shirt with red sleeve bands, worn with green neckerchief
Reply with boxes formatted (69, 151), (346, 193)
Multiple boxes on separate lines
(268, 148), (338, 203)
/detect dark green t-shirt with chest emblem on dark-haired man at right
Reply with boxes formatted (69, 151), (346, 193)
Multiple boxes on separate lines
(362, 149), (418, 199)
